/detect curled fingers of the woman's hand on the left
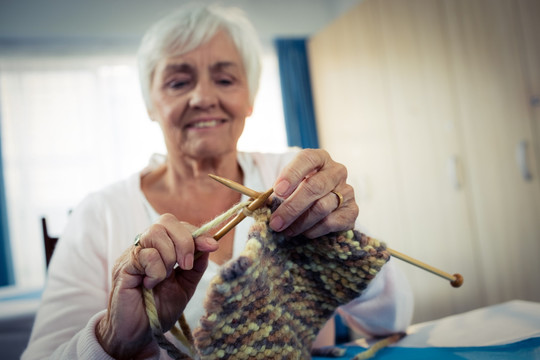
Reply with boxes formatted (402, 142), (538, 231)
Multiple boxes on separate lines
(134, 214), (218, 289)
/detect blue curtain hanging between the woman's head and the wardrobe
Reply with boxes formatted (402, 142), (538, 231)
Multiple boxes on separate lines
(275, 39), (319, 148)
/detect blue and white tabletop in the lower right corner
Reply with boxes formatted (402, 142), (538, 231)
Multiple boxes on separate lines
(314, 300), (540, 360)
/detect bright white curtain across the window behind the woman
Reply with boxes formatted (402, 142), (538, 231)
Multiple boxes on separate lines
(0, 50), (286, 288)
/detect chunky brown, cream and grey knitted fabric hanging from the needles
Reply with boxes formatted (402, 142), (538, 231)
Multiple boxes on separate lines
(193, 201), (390, 359)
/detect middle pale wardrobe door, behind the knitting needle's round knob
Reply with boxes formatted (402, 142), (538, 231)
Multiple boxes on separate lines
(377, 0), (486, 320)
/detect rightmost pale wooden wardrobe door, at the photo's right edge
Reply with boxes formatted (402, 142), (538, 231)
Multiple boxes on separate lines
(445, 0), (540, 303)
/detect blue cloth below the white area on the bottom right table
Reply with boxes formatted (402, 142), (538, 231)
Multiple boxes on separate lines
(313, 337), (540, 360)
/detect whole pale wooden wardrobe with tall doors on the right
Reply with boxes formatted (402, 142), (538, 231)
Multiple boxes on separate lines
(309, 0), (540, 322)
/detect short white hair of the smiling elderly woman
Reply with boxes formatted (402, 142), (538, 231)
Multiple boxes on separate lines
(137, 5), (261, 110)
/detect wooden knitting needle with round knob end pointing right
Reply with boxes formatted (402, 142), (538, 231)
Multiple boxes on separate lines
(209, 174), (463, 288)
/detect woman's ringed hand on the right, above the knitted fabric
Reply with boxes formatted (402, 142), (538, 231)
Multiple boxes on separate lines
(270, 149), (358, 239)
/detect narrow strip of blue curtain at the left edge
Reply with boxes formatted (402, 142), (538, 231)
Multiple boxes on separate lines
(0, 97), (15, 286)
